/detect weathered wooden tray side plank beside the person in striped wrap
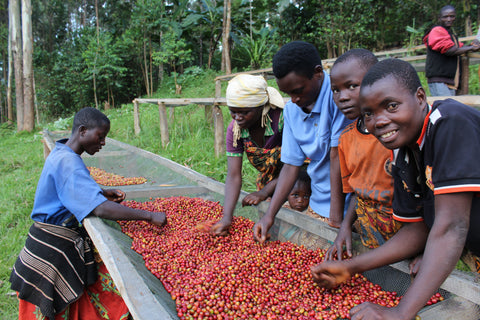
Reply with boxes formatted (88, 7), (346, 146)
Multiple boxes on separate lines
(84, 216), (175, 320)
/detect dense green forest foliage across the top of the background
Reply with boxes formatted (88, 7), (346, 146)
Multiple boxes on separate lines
(5, 0), (478, 121)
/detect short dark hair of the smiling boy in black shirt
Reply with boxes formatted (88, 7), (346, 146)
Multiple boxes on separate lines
(360, 58), (422, 94)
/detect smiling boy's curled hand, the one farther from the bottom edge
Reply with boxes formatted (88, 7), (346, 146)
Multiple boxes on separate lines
(310, 261), (352, 289)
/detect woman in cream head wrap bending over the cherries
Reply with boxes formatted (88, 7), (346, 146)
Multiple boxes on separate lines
(212, 74), (284, 235)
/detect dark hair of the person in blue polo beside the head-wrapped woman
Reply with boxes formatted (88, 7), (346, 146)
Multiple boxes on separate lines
(272, 41), (322, 79)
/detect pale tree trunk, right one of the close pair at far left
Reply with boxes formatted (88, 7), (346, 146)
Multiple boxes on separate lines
(22, 0), (35, 132)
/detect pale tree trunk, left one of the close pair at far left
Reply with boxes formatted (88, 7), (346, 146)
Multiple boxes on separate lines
(10, 0), (24, 131)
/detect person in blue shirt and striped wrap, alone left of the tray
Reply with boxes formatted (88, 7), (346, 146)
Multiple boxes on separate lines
(10, 108), (166, 320)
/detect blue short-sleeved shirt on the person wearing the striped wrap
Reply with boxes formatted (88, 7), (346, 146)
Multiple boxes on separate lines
(31, 139), (107, 226)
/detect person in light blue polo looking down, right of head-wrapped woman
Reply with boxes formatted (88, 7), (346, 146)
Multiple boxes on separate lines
(253, 41), (350, 242)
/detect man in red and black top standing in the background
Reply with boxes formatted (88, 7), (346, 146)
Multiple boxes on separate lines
(423, 5), (480, 96)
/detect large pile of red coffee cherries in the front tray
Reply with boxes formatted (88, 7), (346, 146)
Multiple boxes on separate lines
(119, 197), (442, 319)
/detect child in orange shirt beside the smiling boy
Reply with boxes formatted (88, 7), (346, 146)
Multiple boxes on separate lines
(326, 49), (401, 260)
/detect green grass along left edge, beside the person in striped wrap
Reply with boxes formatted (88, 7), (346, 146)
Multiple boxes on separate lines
(0, 124), (43, 320)
